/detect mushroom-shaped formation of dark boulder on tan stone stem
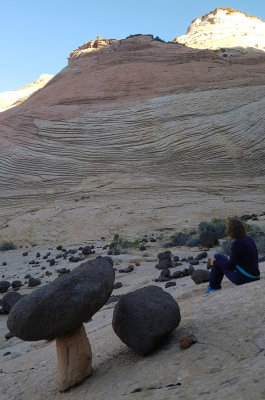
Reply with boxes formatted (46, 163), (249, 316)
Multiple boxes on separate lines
(7, 257), (114, 391)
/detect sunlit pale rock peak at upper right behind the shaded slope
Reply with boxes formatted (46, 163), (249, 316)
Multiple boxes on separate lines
(174, 8), (265, 51)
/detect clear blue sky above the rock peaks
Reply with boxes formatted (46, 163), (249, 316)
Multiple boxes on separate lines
(0, 0), (265, 92)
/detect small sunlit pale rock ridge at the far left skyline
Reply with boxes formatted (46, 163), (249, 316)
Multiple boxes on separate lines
(0, 74), (54, 112)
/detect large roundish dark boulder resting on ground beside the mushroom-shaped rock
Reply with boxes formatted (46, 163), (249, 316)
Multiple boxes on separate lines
(112, 286), (181, 356)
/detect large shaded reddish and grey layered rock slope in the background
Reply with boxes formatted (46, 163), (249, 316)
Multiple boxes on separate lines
(0, 35), (265, 243)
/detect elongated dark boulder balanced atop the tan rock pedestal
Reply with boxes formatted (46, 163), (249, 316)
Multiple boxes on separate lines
(7, 257), (114, 340)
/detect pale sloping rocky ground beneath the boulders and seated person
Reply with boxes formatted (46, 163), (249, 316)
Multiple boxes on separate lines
(0, 234), (265, 400)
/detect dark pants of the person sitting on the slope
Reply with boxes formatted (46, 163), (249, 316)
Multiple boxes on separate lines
(209, 255), (258, 289)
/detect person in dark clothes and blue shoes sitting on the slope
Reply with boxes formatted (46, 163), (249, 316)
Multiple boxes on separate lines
(204, 218), (260, 294)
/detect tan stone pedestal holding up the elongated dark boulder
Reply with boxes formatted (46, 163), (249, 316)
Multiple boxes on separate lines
(56, 325), (92, 392)
